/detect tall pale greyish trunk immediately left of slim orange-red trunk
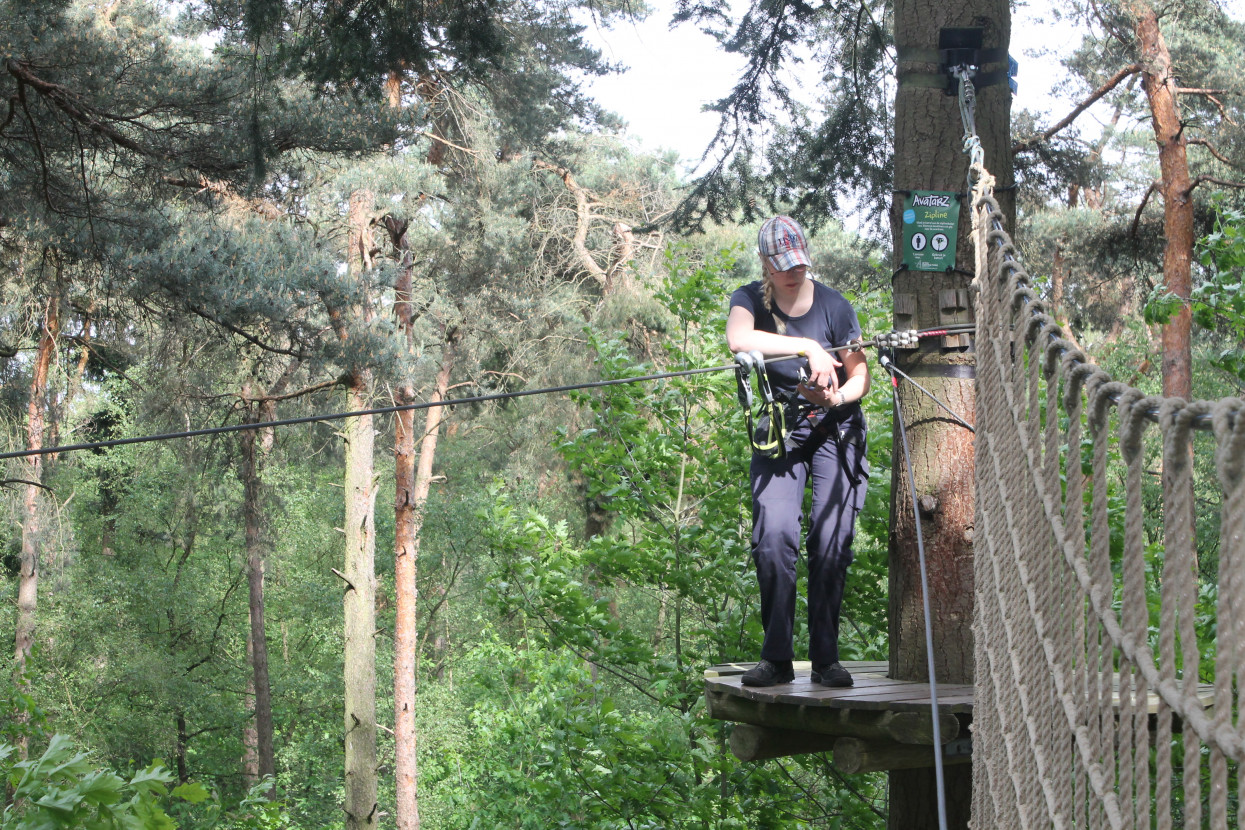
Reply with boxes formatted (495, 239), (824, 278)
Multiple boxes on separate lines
(342, 190), (377, 830)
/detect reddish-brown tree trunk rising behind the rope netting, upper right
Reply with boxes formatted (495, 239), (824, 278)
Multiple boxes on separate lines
(1132, 2), (1194, 399)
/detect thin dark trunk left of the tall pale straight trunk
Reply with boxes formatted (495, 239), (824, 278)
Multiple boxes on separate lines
(240, 398), (276, 796)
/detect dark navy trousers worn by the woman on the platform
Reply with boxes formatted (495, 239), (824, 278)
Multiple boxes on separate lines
(751, 409), (868, 664)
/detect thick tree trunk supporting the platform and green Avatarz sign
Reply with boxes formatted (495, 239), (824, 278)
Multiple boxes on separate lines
(888, 0), (1012, 830)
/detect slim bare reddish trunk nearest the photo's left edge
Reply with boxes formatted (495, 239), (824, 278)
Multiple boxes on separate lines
(14, 292), (60, 755)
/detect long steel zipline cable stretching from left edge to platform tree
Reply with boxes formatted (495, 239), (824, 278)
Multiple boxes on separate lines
(0, 325), (972, 460)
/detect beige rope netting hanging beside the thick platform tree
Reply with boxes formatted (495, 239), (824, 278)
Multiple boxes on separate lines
(972, 162), (1245, 829)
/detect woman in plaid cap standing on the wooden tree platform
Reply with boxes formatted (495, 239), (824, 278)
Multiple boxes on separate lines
(726, 217), (869, 687)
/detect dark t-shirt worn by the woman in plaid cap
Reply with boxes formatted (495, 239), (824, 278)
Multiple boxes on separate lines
(731, 280), (860, 392)
